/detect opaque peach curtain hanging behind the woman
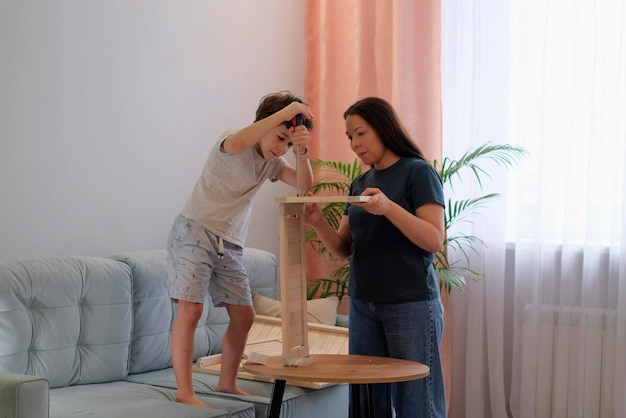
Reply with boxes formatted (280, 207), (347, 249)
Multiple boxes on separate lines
(305, 0), (450, 404)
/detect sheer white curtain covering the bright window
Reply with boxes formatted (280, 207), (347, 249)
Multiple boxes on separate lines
(441, 0), (626, 418)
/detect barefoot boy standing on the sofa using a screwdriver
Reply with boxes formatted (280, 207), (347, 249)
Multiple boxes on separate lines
(167, 92), (313, 407)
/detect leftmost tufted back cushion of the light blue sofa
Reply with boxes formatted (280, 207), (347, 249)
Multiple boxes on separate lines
(0, 257), (132, 388)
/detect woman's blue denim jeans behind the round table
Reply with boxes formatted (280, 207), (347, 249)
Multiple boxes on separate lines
(349, 298), (446, 418)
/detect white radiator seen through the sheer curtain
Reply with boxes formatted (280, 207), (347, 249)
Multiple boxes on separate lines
(520, 305), (626, 418)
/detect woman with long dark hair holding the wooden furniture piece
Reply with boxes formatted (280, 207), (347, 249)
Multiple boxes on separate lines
(306, 97), (446, 418)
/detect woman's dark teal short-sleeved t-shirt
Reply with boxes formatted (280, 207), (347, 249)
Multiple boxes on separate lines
(344, 157), (445, 303)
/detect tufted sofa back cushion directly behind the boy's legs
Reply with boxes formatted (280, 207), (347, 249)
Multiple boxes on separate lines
(112, 248), (276, 374)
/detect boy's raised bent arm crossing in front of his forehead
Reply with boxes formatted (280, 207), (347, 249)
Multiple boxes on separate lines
(222, 102), (313, 154)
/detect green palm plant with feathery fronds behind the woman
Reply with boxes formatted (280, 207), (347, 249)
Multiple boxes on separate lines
(306, 143), (528, 300)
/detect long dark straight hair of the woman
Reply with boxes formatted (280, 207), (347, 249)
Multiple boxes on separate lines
(343, 97), (425, 160)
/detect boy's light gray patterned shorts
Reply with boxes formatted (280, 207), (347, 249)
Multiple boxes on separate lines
(167, 215), (252, 306)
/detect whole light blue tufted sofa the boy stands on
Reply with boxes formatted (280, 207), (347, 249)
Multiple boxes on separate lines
(0, 248), (348, 418)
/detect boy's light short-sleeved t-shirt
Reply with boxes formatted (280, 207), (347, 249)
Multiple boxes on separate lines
(181, 129), (288, 247)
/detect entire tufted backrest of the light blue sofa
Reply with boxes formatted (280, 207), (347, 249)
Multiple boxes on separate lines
(0, 248), (277, 388)
